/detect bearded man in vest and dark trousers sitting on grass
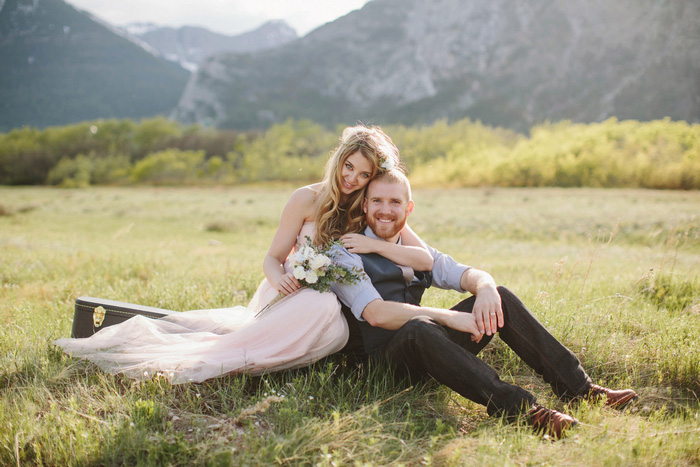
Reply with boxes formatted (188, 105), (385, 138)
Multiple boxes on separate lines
(332, 170), (637, 438)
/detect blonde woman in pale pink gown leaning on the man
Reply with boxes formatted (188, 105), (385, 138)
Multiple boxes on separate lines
(55, 125), (433, 384)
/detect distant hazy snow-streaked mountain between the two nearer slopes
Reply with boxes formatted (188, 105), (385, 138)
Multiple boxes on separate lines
(126, 20), (297, 71)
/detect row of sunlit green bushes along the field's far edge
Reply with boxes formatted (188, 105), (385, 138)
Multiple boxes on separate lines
(0, 117), (700, 190)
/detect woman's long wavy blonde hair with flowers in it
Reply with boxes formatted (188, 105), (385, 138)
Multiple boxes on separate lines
(314, 125), (400, 245)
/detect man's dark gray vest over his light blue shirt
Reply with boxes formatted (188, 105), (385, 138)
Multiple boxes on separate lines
(342, 253), (432, 354)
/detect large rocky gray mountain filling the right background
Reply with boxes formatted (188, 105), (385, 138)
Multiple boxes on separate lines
(172, 0), (700, 130)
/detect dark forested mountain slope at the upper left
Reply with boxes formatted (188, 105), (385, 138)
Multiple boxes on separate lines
(0, 0), (189, 131)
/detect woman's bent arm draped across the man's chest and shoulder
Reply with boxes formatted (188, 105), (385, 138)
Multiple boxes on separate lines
(340, 224), (433, 271)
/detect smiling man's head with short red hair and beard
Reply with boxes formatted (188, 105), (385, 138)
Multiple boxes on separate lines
(364, 180), (413, 242)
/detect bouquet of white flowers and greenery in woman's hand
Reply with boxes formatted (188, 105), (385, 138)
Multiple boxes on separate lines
(255, 236), (365, 316)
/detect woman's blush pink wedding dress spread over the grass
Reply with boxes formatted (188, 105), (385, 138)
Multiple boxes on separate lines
(54, 222), (348, 384)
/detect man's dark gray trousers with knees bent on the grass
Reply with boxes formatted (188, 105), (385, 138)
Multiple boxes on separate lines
(374, 287), (591, 416)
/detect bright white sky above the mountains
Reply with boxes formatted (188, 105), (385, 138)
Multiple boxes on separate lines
(66, 0), (368, 36)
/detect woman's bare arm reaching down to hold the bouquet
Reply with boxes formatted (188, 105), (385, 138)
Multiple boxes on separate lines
(263, 187), (313, 295)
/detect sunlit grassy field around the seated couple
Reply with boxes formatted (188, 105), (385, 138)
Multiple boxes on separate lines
(0, 187), (700, 466)
